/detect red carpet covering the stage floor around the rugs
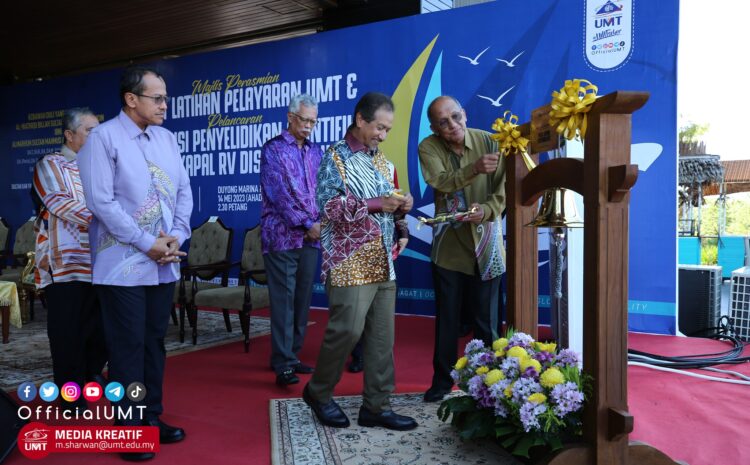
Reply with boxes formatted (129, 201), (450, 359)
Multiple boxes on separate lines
(6, 311), (750, 465)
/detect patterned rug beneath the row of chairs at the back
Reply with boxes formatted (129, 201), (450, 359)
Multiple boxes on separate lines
(0, 305), (271, 391)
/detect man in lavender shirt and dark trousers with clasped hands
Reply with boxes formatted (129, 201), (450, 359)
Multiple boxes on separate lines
(79, 67), (193, 460)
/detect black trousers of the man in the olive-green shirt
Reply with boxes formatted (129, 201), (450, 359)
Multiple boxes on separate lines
(432, 263), (500, 390)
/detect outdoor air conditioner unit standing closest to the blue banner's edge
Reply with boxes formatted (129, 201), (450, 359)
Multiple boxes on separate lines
(678, 265), (721, 336)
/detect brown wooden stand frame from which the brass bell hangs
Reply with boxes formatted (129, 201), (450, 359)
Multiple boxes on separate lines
(506, 92), (675, 465)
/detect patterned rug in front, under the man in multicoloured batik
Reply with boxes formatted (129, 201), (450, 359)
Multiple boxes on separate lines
(270, 393), (520, 465)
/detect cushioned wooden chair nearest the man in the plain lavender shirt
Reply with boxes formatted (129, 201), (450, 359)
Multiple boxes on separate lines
(173, 217), (233, 344)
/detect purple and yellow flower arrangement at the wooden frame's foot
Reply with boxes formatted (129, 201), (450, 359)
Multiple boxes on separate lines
(438, 330), (590, 457)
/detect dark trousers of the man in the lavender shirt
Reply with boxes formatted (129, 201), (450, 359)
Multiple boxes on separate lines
(95, 283), (175, 425)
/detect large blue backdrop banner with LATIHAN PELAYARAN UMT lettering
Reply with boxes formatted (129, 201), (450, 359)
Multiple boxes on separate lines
(0, 0), (679, 334)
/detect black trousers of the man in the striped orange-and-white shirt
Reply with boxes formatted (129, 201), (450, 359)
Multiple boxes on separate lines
(44, 281), (107, 399)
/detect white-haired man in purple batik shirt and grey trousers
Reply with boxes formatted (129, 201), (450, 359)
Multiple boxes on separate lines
(260, 94), (322, 386)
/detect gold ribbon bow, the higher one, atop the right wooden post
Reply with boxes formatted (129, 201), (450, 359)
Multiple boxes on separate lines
(549, 79), (599, 140)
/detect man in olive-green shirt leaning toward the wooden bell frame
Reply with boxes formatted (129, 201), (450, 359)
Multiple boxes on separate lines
(419, 96), (505, 402)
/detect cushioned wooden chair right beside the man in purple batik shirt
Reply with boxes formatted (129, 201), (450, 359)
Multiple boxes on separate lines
(195, 225), (269, 352)
